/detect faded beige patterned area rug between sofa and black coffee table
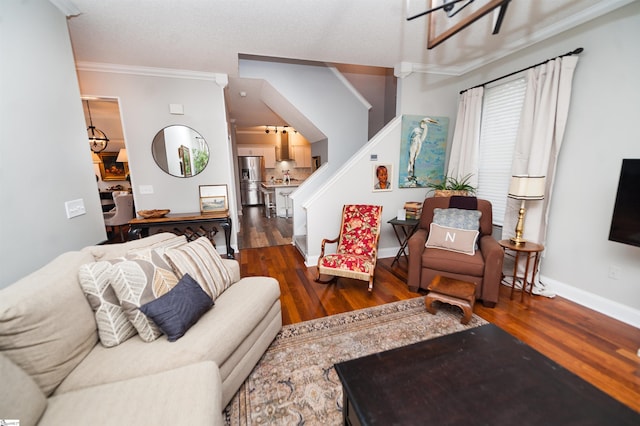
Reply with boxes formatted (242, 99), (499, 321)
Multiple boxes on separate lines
(225, 297), (487, 426)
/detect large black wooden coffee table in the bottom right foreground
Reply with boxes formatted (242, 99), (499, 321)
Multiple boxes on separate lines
(335, 324), (640, 426)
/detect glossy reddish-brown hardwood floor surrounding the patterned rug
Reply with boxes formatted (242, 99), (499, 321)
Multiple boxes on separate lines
(237, 244), (640, 412)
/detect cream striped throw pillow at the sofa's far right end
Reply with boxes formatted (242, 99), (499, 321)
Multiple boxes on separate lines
(165, 237), (232, 300)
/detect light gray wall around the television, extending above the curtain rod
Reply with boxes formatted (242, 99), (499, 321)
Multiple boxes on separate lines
(402, 2), (640, 326)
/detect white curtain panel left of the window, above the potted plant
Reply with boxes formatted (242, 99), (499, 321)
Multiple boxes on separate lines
(447, 87), (484, 187)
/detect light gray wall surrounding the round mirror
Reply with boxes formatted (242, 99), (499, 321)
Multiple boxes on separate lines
(78, 68), (238, 251)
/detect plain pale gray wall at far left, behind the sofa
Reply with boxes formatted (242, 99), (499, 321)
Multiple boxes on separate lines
(0, 0), (106, 287)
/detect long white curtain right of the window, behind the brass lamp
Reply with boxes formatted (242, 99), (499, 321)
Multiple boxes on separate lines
(502, 56), (578, 294)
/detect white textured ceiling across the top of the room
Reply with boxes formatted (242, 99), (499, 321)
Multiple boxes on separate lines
(65, 0), (634, 126)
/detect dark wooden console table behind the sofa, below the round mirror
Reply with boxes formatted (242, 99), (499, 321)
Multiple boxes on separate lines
(129, 213), (234, 259)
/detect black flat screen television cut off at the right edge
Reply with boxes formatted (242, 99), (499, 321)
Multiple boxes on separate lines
(609, 158), (640, 247)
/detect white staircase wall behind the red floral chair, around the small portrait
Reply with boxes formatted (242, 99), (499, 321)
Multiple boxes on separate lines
(302, 70), (457, 265)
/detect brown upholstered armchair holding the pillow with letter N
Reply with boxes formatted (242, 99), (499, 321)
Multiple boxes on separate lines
(407, 197), (504, 307)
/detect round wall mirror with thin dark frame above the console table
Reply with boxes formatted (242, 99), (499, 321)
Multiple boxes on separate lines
(151, 125), (209, 177)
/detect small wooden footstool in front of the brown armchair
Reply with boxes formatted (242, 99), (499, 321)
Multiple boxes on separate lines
(424, 275), (476, 324)
